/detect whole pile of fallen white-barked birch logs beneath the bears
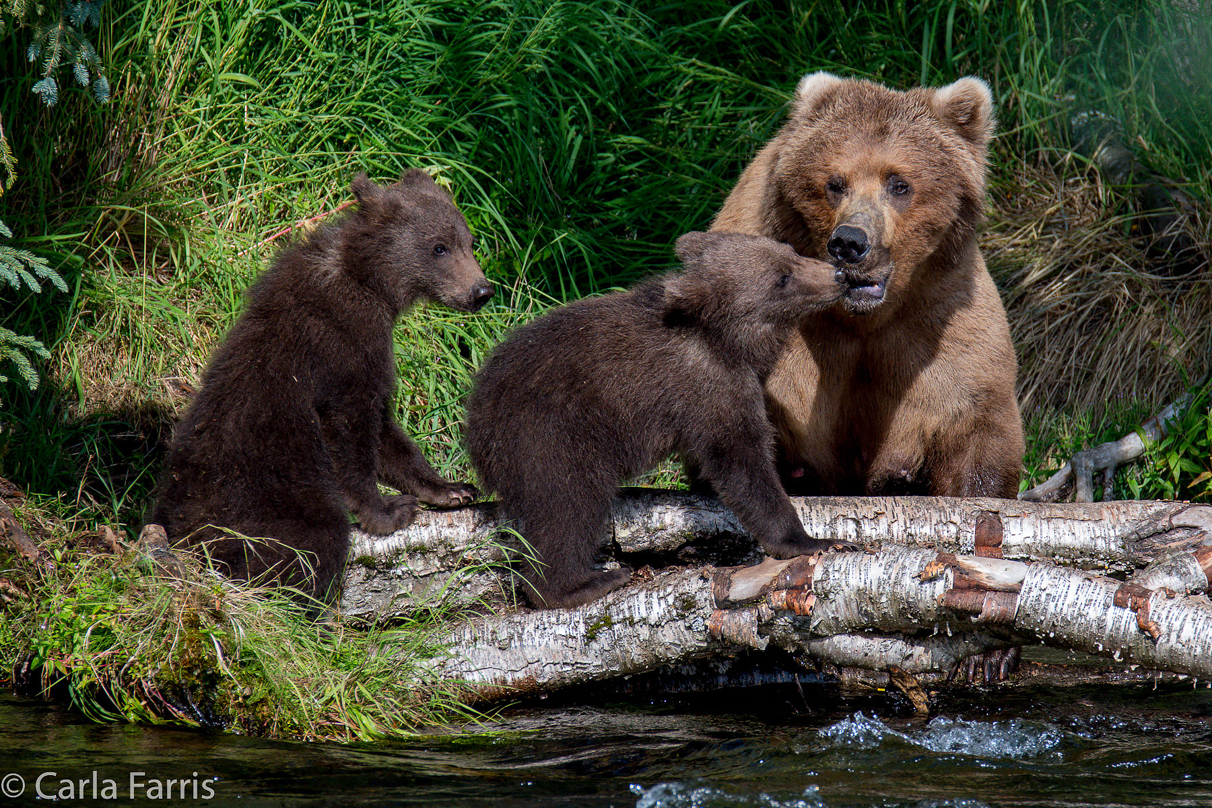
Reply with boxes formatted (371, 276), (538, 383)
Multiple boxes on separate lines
(342, 491), (1212, 699)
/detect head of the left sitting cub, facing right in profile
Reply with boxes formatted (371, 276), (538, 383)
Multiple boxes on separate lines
(345, 168), (493, 311)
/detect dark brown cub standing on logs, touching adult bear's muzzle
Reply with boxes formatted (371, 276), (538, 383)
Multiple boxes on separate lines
(467, 233), (842, 608)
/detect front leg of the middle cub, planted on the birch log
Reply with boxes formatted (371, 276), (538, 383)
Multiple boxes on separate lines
(698, 433), (858, 558)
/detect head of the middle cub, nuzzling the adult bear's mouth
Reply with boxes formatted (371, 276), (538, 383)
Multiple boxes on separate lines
(665, 231), (845, 343)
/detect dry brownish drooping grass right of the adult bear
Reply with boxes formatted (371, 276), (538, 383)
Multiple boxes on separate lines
(982, 159), (1212, 423)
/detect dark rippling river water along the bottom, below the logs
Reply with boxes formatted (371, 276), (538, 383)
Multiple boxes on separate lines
(0, 684), (1212, 808)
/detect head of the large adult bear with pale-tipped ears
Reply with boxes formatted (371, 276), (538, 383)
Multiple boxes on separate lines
(771, 73), (994, 315)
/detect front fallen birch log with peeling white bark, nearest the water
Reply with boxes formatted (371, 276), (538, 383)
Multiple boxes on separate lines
(436, 548), (1212, 700)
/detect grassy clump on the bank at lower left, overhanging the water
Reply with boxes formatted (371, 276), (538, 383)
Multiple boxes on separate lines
(0, 525), (492, 741)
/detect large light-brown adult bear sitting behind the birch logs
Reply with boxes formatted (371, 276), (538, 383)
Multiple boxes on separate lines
(711, 73), (1023, 498)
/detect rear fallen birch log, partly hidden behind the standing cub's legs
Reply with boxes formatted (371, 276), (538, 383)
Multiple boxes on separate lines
(342, 489), (1212, 620)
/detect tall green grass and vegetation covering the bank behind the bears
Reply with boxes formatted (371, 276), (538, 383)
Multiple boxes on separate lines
(0, 0), (1212, 731)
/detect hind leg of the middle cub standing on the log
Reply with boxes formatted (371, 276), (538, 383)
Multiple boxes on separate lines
(514, 480), (631, 609)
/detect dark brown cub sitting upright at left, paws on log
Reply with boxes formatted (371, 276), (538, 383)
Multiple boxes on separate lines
(150, 170), (492, 600)
